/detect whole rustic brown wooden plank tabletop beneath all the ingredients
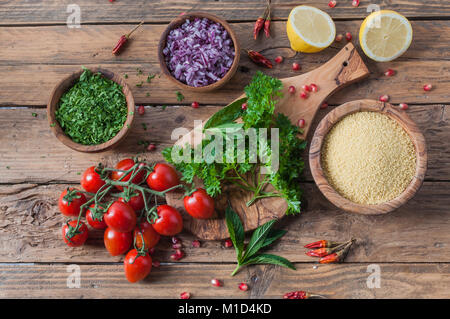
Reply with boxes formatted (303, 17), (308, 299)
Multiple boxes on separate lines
(0, 0), (450, 298)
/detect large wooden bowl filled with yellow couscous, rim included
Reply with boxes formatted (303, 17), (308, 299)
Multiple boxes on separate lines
(309, 100), (427, 215)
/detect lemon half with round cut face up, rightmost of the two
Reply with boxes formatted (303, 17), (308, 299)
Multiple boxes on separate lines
(359, 10), (413, 62)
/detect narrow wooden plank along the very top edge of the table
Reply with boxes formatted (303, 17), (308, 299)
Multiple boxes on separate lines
(0, 0), (450, 25)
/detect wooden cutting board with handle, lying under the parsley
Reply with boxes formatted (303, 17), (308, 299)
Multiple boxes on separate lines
(166, 43), (369, 240)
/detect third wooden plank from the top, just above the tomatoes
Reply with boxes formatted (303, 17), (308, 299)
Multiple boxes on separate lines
(0, 105), (450, 183)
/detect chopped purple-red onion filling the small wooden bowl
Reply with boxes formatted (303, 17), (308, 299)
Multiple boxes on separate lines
(163, 18), (234, 87)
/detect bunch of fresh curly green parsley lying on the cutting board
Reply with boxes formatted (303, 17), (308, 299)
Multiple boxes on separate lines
(163, 72), (306, 214)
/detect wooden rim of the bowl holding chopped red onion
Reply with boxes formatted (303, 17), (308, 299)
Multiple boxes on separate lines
(158, 11), (241, 92)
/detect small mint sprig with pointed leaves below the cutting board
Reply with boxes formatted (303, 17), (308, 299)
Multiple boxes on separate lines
(225, 206), (295, 276)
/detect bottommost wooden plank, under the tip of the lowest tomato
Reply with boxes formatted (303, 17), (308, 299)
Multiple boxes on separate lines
(0, 263), (450, 300)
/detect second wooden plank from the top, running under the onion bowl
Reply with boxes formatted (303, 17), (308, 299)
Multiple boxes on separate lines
(0, 21), (450, 106)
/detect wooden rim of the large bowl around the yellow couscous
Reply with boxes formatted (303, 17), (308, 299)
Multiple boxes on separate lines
(309, 100), (427, 215)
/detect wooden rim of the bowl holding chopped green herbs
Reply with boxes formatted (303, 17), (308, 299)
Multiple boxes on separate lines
(47, 67), (135, 153)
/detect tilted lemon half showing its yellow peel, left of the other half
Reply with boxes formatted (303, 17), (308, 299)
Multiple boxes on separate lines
(287, 6), (336, 53)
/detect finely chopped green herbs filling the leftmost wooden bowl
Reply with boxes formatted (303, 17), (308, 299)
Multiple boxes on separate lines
(55, 68), (128, 145)
